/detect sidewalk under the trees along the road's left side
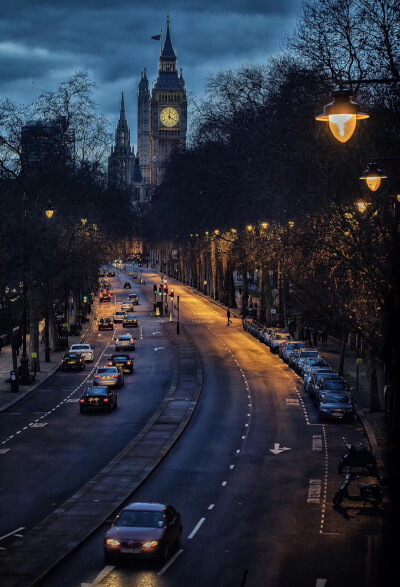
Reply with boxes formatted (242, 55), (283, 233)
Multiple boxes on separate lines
(0, 300), (98, 412)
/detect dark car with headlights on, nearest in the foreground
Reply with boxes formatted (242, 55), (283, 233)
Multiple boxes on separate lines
(104, 502), (182, 564)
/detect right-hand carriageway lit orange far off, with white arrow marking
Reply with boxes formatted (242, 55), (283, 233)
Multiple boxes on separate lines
(38, 272), (383, 587)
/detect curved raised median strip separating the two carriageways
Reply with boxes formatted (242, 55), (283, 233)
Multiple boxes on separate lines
(0, 323), (202, 587)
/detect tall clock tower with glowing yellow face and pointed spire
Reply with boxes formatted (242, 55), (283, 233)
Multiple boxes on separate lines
(150, 17), (187, 187)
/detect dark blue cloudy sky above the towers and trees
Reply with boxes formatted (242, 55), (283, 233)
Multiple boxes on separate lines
(0, 0), (301, 147)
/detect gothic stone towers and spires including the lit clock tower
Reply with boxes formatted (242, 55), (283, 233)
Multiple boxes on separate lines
(108, 19), (187, 205)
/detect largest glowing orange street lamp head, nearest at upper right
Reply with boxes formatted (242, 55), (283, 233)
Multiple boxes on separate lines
(315, 89), (369, 143)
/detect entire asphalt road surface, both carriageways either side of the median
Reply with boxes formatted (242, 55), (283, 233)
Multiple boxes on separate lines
(0, 271), (383, 587)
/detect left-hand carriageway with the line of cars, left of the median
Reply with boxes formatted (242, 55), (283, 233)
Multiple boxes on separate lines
(0, 278), (174, 548)
